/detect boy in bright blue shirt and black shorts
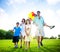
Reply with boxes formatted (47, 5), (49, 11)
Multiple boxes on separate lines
(13, 22), (21, 48)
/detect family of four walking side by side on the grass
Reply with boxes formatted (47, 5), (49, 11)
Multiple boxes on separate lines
(13, 11), (54, 49)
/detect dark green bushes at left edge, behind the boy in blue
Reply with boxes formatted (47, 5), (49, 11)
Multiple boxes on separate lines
(0, 29), (13, 39)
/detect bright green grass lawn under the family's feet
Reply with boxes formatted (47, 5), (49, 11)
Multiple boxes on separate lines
(0, 39), (60, 52)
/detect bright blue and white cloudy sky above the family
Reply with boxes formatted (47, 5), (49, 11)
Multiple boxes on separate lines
(0, 0), (60, 37)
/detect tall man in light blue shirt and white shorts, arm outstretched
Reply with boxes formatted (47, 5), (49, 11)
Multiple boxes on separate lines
(33, 11), (54, 48)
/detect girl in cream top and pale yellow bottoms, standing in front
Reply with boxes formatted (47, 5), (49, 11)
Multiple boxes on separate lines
(25, 19), (31, 49)
